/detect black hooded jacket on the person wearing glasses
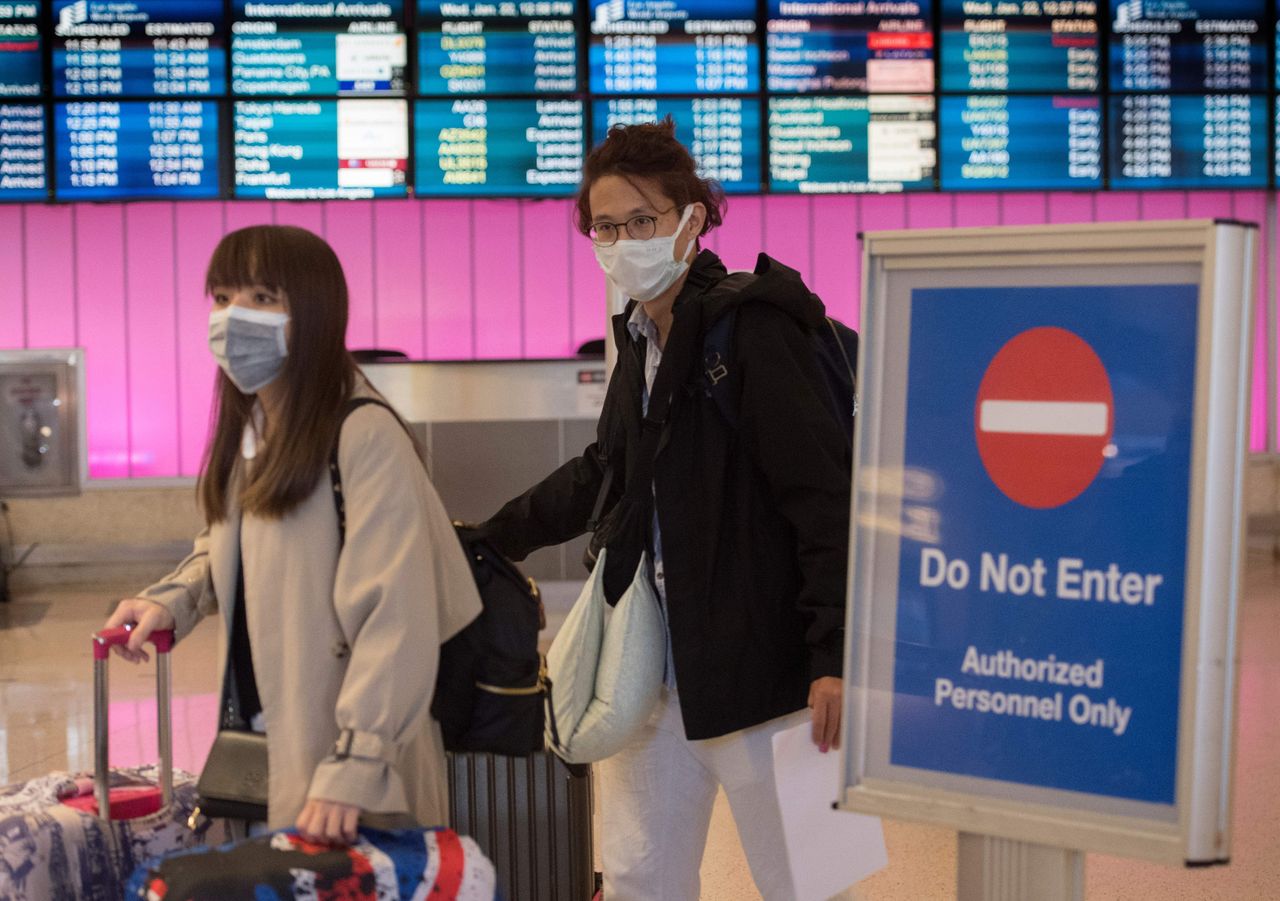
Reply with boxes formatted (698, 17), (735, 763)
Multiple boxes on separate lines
(480, 251), (850, 740)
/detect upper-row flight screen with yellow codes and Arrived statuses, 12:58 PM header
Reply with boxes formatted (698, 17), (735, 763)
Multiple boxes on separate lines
(416, 0), (579, 97)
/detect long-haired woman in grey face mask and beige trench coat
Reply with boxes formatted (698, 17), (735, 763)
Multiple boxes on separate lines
(108, 225), (480, 842)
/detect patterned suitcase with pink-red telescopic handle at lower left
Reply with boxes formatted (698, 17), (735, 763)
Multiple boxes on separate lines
(0, 628), (201, 901)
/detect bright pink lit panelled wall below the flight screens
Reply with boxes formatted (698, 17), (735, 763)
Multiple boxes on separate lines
(0, 192), (1276, 479)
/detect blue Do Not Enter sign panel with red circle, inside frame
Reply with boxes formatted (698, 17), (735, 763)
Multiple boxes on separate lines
(890, 284), (1198, 805)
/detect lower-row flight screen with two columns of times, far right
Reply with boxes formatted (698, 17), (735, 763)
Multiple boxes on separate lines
(1108, 93), (1268, 188)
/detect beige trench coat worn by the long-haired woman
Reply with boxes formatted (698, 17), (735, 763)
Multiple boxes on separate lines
(140, 396), (480, 828)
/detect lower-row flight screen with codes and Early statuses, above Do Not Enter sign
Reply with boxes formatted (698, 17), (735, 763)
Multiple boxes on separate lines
(940, 95), (1103, 191)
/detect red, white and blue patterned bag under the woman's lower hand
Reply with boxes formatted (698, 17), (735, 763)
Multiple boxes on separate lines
(124, 828), (494, 901)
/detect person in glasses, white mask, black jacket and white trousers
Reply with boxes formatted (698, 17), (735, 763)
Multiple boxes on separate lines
(476, 119), (850, 901)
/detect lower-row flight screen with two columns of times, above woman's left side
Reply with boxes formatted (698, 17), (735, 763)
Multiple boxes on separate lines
(54, 100), (219, 200)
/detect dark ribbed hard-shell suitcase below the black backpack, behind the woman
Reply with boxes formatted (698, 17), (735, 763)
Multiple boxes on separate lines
(448, 751), (596, 901)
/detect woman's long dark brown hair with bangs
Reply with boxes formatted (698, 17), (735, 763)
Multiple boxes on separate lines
(197, 225), (357, 525)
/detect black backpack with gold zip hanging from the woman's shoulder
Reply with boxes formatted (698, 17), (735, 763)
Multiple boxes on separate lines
(329, 398), (550, 756)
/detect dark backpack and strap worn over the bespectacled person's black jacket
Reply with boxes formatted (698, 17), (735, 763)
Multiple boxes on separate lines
(703, 253), (858, 437)
